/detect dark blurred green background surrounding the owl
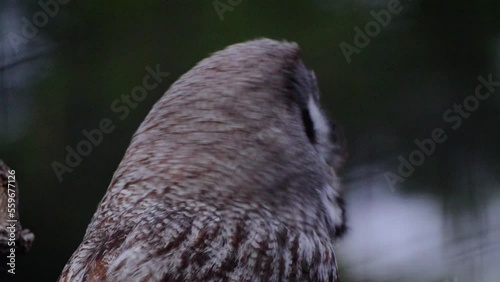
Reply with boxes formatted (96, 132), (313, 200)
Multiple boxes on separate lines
(0, 0), (500, 282)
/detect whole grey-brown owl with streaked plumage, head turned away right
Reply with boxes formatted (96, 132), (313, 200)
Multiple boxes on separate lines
(60, 39), (345, 281)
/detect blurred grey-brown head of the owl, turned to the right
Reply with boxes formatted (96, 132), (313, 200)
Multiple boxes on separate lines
(108, 39), (345, 236)
